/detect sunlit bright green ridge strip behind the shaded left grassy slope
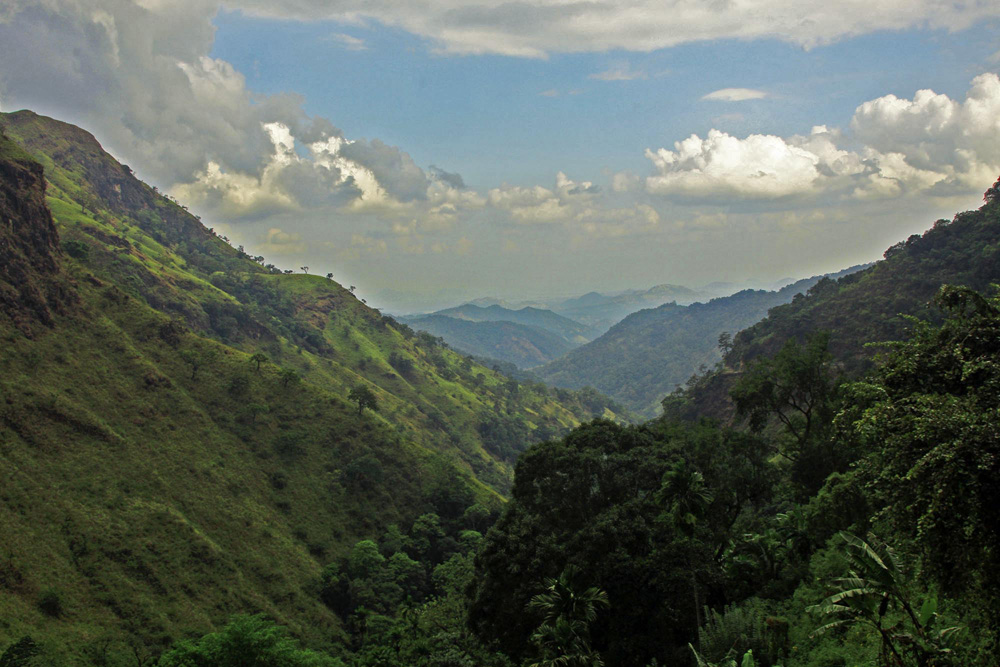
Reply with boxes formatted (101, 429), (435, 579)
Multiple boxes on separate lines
(0, 111), (616, 489)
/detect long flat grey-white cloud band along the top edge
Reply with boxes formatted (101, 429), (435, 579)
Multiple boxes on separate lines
(227, 0), (1000, 58)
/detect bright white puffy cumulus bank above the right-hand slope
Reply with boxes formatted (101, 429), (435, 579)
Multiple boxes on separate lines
(644, 73), (1000, 200)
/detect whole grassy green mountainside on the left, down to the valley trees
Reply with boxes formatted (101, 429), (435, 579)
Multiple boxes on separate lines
(0, 111), (613, 664)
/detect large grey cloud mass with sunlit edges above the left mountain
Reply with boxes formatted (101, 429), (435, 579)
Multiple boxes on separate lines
(0, 0), (475, 235)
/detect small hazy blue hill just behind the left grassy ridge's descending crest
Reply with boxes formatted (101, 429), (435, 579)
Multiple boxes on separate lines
(396, 315), (574, 368)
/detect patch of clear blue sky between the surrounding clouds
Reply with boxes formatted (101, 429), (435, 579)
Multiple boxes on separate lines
(212, 11), (1000, 188)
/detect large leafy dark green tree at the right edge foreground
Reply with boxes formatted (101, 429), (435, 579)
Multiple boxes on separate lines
(845, 286), (1000, 604)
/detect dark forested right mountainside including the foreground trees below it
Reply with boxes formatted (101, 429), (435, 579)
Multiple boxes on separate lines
(470, 187), (1000, 667)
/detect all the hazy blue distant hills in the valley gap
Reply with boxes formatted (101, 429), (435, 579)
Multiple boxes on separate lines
(400, 269), (854, 374)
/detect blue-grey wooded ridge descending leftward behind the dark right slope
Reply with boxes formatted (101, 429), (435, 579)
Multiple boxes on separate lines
(534, 267), (862, 416)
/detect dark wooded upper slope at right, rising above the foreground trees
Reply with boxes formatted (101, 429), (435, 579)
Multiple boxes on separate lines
(672, 182), (1000, 418)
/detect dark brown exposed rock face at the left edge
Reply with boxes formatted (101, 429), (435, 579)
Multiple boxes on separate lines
(0, 134), (70, 336)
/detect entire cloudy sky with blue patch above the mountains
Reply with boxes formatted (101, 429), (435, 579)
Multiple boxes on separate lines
(0, 0), (1000, 310)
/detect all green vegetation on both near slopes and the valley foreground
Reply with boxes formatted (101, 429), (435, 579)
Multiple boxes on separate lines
(0, 113), (1000, 667)
